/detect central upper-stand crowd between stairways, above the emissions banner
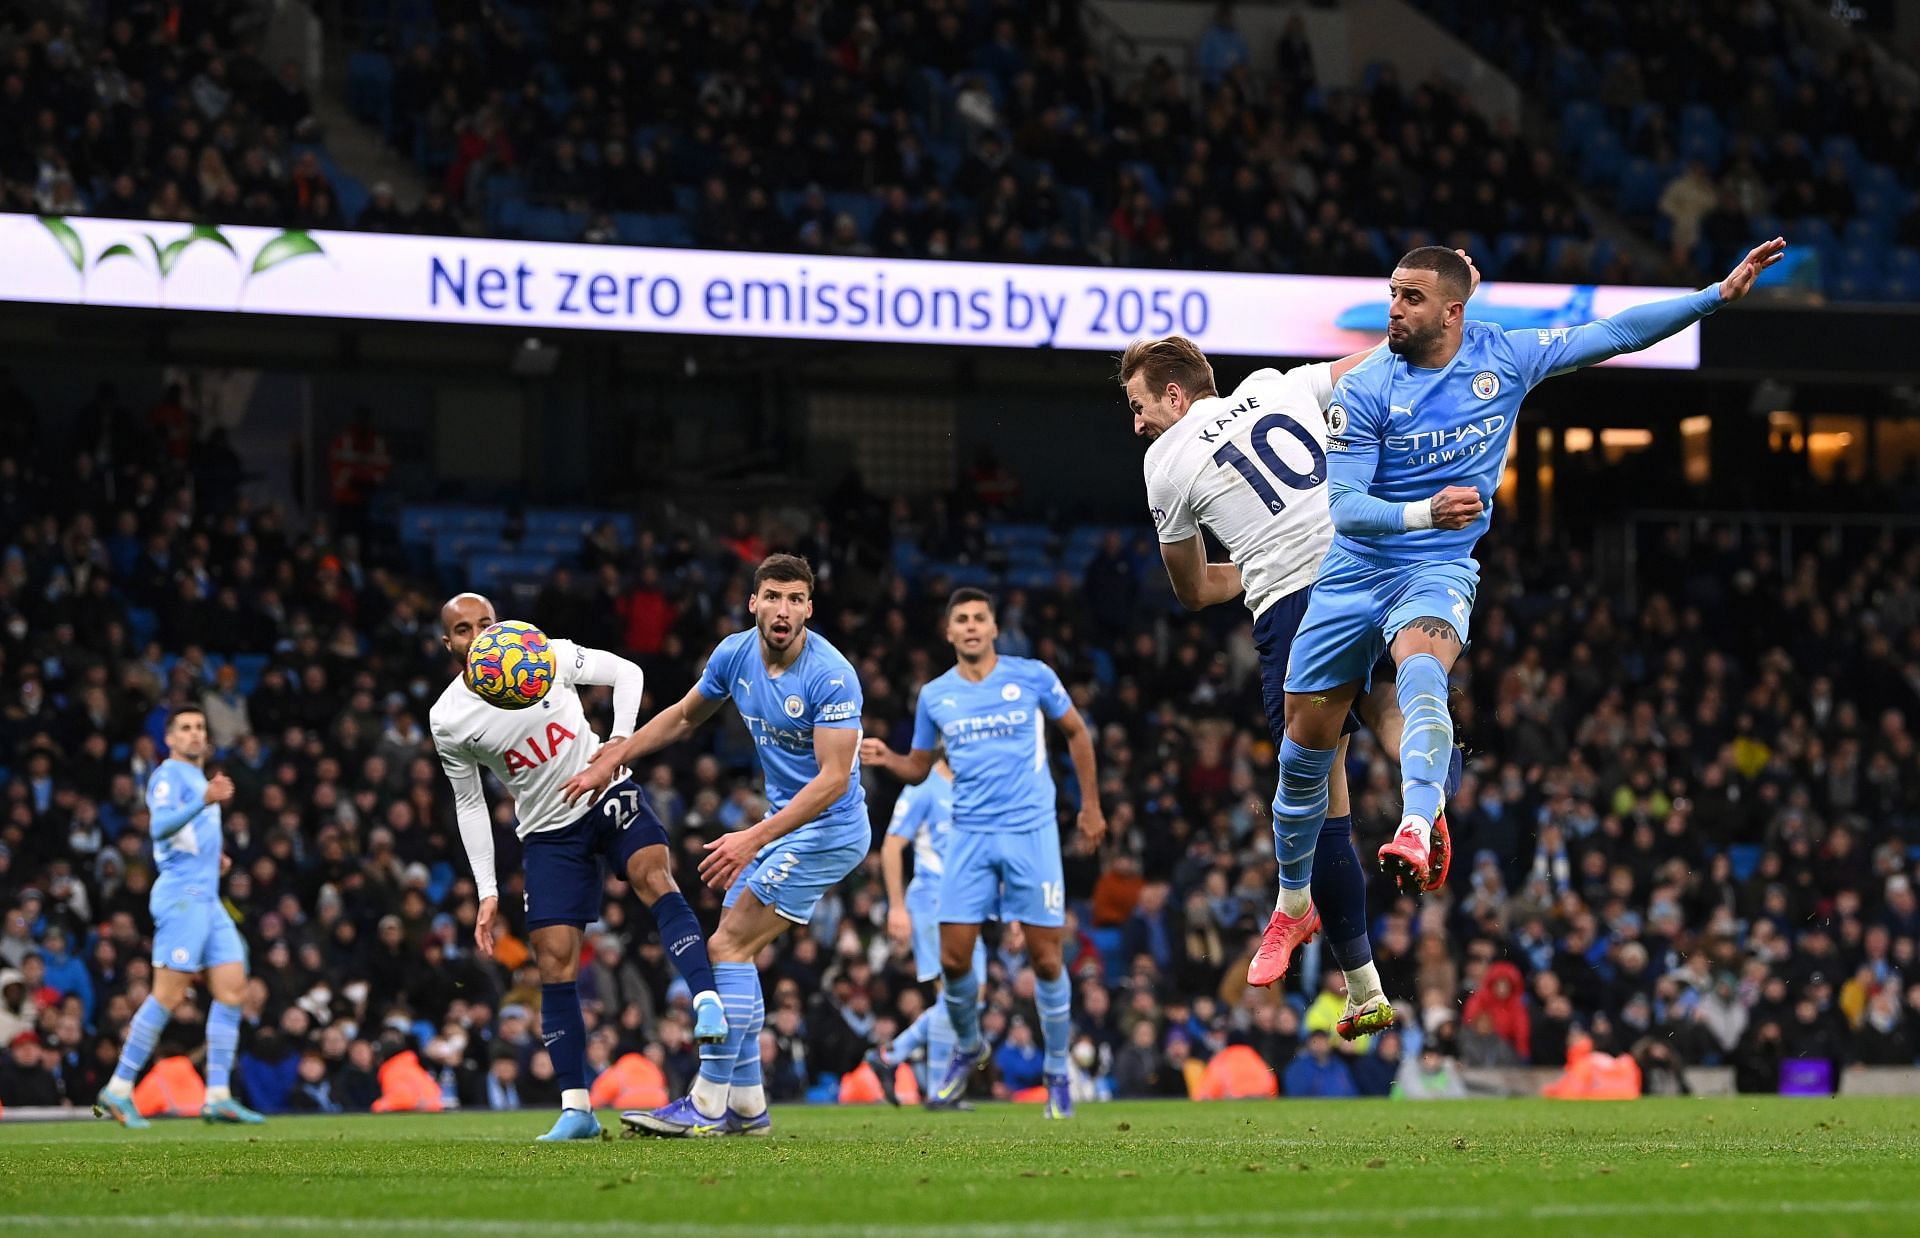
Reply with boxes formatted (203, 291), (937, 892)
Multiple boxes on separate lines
(341, 0), (1605, 278)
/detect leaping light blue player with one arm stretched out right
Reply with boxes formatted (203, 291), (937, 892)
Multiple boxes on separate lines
(1275, 238), (1786, 902)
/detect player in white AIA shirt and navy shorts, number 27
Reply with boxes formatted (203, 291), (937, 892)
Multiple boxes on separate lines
(432, 593), (728, 1142)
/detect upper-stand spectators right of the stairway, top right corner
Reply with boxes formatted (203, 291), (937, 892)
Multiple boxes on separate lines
(1421, 0), (1920, 298)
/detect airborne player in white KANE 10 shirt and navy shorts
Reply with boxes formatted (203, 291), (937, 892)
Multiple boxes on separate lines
(1119, 255), (1480, 1040)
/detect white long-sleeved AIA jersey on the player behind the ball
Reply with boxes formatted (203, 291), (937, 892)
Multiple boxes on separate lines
(430, 639), (645, 898)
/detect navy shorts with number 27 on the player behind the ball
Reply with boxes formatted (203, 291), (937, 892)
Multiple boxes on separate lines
(520, 779), (666, 929)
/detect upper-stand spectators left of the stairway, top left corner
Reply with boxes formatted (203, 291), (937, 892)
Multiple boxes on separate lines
(0, 0), (360, 226)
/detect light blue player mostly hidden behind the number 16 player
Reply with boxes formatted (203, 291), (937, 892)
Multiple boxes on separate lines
(866, 749), (987, 1109)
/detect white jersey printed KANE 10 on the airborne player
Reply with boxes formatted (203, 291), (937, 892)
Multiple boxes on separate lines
(1146, 365), (1340, 616)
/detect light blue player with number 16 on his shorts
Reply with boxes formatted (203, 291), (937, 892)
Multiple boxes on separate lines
(860, 589), (1106, 1117)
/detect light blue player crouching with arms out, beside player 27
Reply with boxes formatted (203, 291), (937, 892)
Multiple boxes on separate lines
(564, 555), (874, 1138)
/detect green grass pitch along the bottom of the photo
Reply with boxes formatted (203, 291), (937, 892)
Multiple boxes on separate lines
(0, 1098), (1920, 1238)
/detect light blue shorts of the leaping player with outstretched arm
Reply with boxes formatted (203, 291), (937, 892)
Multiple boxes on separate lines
(1286, 545), (1480, 693)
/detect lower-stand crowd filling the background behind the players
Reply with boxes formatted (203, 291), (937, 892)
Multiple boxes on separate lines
(0, 374), (1920, 1111)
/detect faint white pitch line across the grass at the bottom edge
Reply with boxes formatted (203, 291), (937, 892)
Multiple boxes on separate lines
(0, 1200), (1920, 1238)
